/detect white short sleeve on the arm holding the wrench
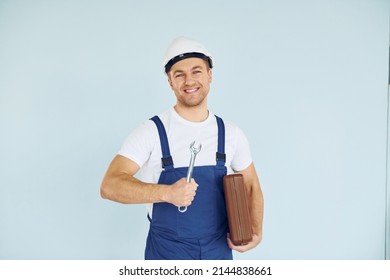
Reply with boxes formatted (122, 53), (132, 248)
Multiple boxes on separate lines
(118, 120), (157, 168)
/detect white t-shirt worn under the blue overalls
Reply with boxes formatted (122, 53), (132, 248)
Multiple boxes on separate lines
(118, 108), (252, 214)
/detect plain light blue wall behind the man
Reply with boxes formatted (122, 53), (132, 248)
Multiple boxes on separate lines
(0, 0), (390, 259)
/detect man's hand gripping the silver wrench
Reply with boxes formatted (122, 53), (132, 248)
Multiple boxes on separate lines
(165, 178), (198, 207)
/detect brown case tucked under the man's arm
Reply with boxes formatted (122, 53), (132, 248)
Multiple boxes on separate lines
(223, 174), (252, 245)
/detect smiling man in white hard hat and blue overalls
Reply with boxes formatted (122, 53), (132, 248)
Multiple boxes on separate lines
(101, 37), (263, 259)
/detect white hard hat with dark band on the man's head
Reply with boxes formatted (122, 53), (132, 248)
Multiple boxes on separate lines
(164, 37), (213, 73)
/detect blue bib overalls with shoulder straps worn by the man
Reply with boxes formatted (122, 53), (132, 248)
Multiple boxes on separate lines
(145, 116), (233, 260)
